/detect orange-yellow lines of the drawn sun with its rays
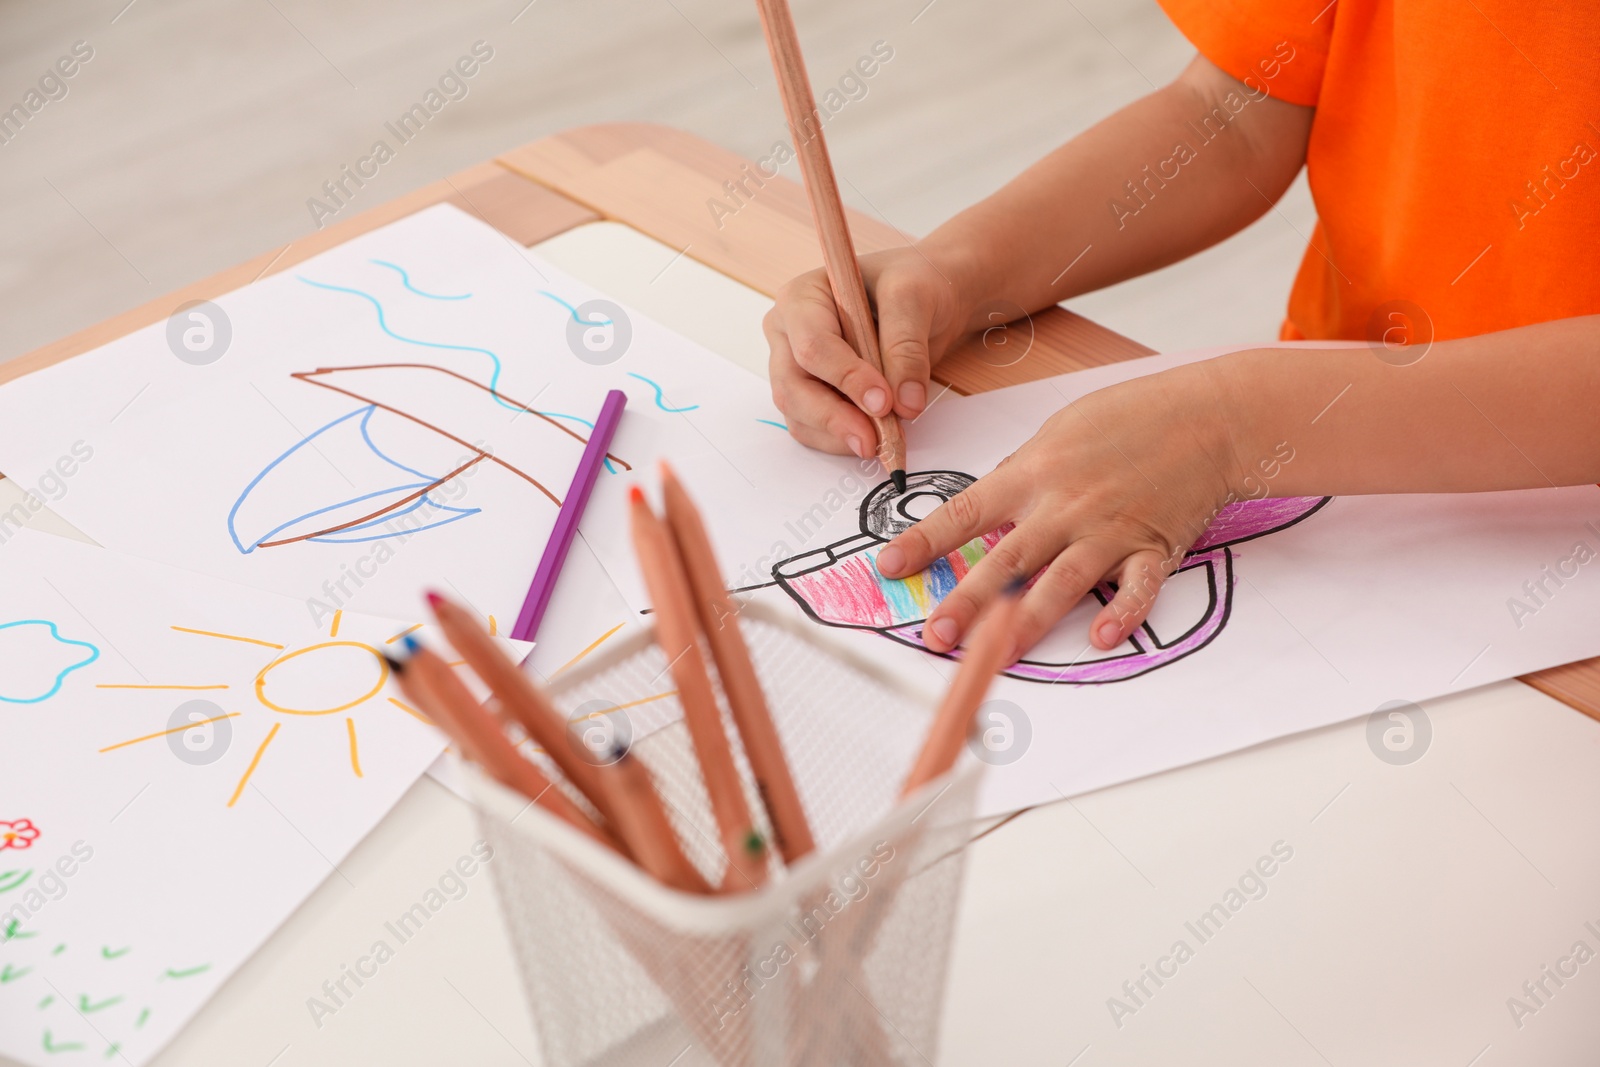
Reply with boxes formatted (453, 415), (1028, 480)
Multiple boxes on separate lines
(96, 611), (496, 808)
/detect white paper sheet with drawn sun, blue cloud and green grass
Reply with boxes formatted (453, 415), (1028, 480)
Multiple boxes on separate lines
(0, 531), (526, 1064)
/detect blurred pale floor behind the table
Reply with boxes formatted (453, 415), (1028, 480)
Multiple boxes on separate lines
(0, 0), (1315, 360)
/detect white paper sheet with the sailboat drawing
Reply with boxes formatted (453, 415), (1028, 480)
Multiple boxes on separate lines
(0, 205), (784, 630)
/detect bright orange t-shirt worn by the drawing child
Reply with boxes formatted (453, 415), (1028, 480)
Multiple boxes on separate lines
(1162, 0), (1600, 339)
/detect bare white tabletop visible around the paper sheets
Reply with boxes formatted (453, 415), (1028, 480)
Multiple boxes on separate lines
(0, 222), (1600, 1067)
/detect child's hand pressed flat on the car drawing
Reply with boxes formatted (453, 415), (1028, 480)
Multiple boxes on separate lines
(877, 363), (1242, 661)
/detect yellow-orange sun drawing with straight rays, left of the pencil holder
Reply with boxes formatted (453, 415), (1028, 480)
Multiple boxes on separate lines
(96, 611), (427, 808)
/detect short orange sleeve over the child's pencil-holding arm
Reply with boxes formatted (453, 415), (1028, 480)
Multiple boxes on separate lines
(1160, 0), (1338, 107)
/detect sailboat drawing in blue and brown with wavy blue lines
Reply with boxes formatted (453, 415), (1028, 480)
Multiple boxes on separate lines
(227, 259), (643, 555)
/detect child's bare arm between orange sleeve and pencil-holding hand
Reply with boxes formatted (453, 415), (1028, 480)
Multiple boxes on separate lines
(920, 59), (1312, 328)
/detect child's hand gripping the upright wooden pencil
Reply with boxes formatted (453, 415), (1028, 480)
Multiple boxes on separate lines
(762, 248), (963, 459)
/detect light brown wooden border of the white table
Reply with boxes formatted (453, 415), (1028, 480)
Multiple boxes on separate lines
(0, 123), (1600, 720)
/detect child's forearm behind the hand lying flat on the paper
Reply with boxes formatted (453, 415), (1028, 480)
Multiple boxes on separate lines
(1208, 315), (1600, 496)
